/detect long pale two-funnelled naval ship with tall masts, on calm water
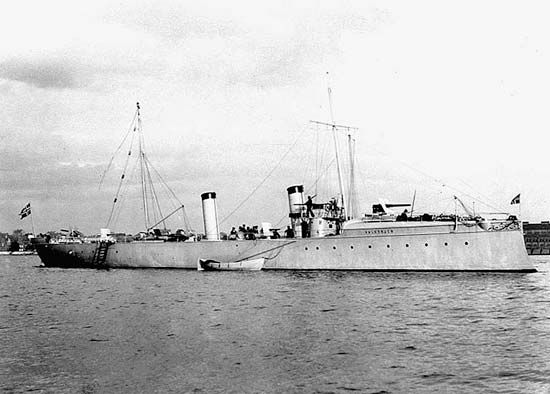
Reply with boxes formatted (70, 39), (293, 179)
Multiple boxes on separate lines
(37, 101), (536, 273)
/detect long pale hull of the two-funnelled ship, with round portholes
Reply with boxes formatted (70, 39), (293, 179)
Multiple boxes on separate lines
(39, 224), (534, 272)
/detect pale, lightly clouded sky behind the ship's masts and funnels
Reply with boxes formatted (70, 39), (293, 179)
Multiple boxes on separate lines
(0, 0), (550, 234)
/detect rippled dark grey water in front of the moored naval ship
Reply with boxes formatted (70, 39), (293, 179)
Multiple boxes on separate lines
(0, 256), (550, 393)
